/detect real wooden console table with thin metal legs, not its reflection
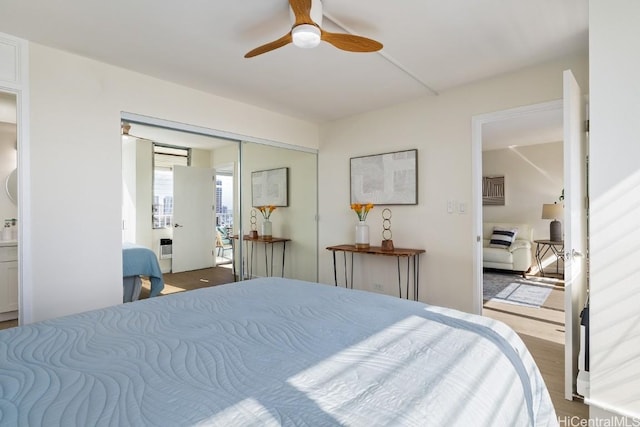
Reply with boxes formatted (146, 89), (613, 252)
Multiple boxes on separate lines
(327, 245), (425, 301)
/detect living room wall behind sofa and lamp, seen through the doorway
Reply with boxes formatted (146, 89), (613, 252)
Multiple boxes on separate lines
(482, 142), (564, 272)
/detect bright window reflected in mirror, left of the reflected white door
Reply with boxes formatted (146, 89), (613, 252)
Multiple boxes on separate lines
(152, 144), (191, 228)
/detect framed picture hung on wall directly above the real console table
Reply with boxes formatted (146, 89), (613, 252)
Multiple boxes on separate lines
(350, 149), (418, 205)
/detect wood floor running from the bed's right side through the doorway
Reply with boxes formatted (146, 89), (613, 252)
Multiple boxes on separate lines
(483, 272), (589, 425)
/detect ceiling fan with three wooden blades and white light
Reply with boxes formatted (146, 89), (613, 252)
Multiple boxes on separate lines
(244, 0), (382, 58)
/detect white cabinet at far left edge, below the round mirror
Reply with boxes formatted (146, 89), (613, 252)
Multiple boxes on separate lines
(0, 242), (18, 321)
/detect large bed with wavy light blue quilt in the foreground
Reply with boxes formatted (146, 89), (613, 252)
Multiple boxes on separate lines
(0, 278), (557, 426)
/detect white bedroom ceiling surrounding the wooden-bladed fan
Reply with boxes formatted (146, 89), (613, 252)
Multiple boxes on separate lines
(0, 0), (588, 145)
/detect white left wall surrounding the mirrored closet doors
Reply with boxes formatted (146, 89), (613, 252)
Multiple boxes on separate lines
(23, 44), (318, 323)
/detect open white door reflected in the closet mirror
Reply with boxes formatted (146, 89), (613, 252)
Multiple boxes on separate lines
(171, 166), (216, 273)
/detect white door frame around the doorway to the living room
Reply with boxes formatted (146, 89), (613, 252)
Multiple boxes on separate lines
(471, 99), (563, 315)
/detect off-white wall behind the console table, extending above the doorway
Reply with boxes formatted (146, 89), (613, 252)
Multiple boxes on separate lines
(319, 56), (587, 311)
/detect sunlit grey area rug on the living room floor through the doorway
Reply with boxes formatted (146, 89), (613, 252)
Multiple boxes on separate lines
(482, 272), (561, 307)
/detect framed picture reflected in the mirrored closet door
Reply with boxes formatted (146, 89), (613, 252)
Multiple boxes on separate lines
(251, 168), (289, 207)
